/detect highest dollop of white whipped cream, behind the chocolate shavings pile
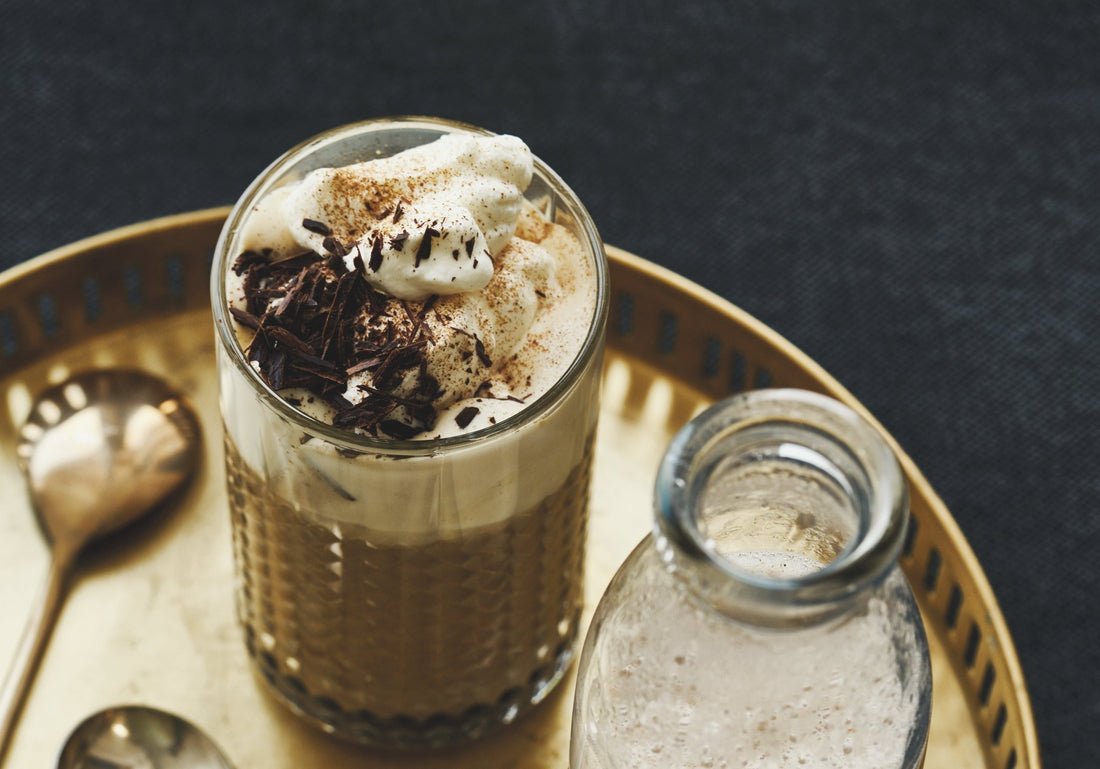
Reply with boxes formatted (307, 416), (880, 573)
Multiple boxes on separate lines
(242, 134), (534, 301)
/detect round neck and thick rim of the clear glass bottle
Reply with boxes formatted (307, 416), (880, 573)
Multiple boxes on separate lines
(655, 389), (909, 627)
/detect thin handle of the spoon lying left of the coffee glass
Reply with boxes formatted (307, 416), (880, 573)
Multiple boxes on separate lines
(0, 543), (77, 762)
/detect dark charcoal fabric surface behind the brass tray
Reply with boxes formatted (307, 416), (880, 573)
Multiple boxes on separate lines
(0, 0), (1100, 767)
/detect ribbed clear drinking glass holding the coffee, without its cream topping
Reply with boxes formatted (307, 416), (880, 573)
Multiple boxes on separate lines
(212, 118), (607, 746)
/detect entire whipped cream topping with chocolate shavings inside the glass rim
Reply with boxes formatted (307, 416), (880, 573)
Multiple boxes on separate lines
(226, 134), (595, 439)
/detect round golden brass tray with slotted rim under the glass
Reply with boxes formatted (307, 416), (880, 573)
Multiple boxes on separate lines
(0, 209), (1040, 769)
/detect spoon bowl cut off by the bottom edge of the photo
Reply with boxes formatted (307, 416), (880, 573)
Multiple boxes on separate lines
(57, 705), (232, 769)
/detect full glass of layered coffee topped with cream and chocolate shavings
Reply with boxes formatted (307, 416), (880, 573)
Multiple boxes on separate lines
(212, 119), (606, 746)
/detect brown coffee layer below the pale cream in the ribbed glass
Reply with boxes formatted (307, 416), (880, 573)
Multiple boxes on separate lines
(227, 437), (592, 719)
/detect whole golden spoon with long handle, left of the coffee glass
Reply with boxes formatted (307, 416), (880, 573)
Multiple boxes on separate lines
(0, 370), (199, 759)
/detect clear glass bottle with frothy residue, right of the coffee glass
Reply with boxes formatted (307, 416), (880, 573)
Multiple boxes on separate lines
(571, 389), (932, 769)
